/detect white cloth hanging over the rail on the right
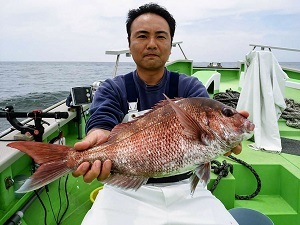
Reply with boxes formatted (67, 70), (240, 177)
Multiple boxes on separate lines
(237, 51), (288, 152)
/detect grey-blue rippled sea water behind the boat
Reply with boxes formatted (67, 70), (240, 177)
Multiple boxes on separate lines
(0, 62), (300, 133)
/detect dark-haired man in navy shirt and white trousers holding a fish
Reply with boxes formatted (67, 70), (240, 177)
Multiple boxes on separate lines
(73, 3), (248, 225)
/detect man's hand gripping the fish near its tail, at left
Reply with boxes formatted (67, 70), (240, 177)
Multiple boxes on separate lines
(73, 129), (111, 183)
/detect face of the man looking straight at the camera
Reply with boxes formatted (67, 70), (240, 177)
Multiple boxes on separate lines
(129, 13), (171, 70)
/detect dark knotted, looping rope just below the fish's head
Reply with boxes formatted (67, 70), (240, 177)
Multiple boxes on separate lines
(210, 155), (261, 200)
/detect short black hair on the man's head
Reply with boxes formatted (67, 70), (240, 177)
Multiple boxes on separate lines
(126, 3), (176, 44)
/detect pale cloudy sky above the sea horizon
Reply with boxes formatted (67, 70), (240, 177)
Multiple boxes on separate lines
(0, 0), (300, 62)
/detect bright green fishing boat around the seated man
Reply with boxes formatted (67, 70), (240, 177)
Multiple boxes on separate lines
(0, 42), (300, 225)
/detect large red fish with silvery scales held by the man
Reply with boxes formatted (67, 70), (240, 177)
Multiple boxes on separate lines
(8, 95), (254, 193)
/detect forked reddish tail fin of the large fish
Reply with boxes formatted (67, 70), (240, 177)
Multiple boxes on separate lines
(7, 141), (73, 193)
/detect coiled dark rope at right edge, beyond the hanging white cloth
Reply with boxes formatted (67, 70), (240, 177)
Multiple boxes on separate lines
(281, 99), (300, 129)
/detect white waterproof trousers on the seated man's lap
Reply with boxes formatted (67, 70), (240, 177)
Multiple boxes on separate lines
(82, 180), (238, 225)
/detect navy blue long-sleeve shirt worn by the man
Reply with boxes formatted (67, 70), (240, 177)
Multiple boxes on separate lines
(86, 67), (209, 132)
